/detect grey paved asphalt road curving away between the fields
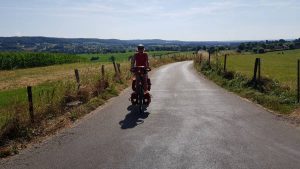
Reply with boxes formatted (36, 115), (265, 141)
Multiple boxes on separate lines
(0, 62), (300, 169)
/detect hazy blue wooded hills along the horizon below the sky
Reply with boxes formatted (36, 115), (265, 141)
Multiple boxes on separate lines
(0, 37), (241, 53)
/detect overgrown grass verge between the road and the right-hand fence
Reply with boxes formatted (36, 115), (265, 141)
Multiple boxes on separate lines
(194, 60), (298, 115)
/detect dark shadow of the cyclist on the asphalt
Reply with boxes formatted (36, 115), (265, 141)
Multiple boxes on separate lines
(119, 105), (150, 129)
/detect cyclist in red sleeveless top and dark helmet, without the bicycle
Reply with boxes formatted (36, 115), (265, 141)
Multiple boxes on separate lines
(131, 44), (150, 93)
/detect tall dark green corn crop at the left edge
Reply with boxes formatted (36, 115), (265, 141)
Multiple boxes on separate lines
(0, 52), (84, 70)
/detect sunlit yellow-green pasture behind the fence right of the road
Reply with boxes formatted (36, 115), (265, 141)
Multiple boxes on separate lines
(227, 49), (300, 89)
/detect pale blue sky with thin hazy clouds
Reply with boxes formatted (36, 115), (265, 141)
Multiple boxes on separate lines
(0, 0), (300, 41)
